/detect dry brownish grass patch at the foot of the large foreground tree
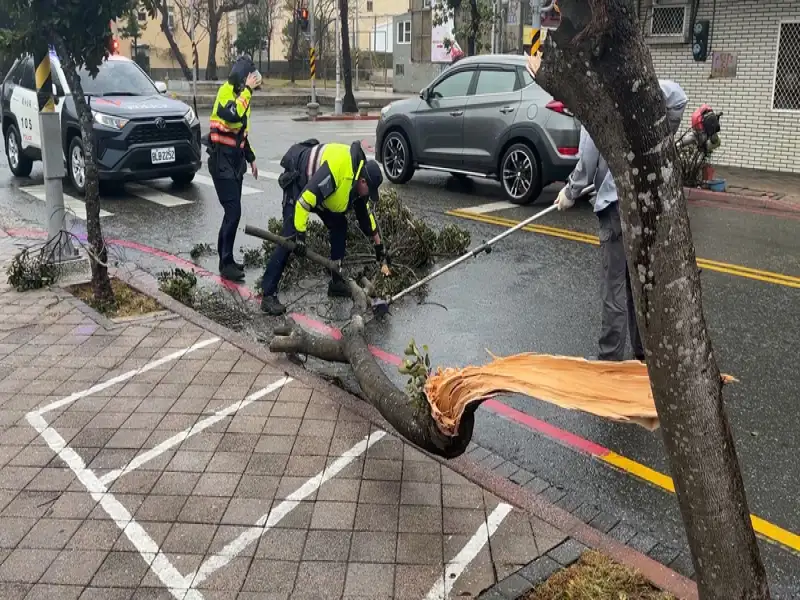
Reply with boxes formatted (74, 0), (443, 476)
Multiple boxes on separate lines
(522, 550), (677, 600)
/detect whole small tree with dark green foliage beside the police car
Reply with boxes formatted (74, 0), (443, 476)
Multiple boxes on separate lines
(0, 0), (135, 306)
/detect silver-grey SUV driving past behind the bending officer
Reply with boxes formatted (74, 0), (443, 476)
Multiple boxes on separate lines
(375, 54), (580, 204)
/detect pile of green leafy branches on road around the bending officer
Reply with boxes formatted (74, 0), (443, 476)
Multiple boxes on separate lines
(247, 189), (470, 296)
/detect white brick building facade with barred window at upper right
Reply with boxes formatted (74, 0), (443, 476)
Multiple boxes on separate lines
(639, 0), (800, 172)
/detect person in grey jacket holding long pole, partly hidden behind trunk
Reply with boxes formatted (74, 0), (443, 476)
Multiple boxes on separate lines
(555, 79), (688, 361)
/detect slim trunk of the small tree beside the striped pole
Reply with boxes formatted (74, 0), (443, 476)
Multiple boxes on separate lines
(52, 35), (115, 306)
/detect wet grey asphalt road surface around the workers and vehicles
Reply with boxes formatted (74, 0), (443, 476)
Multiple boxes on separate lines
(0, 111), (800, 598)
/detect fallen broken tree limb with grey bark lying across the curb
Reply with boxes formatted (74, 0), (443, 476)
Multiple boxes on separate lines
(245, 225), (481, 458)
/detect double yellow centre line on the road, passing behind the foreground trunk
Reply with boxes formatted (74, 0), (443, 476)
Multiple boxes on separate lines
(445, 210), (800, 289)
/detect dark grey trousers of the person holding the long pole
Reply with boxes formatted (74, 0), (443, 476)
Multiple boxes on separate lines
(597, 202), (644, 360)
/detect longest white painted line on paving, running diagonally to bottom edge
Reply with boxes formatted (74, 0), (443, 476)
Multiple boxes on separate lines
(27, 412), (203, 600)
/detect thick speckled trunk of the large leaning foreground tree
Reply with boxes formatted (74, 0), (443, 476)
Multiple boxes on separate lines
(537, 0), (769, 600)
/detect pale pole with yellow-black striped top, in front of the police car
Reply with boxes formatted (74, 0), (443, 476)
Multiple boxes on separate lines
(36, 46), (78, 262)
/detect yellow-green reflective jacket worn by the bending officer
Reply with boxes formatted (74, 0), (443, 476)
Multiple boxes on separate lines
(294, 143), (377, 235)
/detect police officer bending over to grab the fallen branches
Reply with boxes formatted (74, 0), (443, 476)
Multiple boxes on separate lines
(261, 139), (389, 316)
